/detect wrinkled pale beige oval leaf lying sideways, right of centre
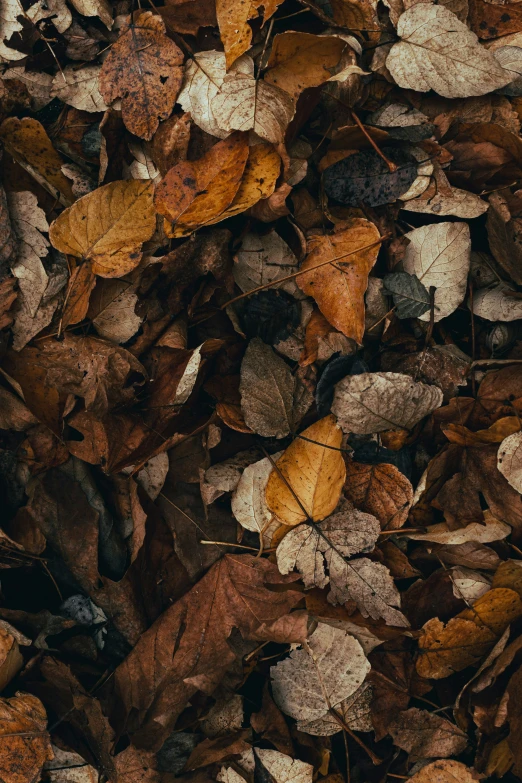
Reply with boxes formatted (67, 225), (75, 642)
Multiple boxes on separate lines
(332, 372), (442, 435)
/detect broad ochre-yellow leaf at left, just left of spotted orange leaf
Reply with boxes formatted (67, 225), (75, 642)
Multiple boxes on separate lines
(49, 179), (156, 277)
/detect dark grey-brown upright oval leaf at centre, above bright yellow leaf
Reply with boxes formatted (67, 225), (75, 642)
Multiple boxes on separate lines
(239, 337), (312, 438)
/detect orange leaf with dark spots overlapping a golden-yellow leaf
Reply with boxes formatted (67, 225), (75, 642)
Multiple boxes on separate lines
(154, 133), (249, 237)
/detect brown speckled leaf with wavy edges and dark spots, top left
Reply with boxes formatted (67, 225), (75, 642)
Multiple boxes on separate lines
(100, 11), (183, 140)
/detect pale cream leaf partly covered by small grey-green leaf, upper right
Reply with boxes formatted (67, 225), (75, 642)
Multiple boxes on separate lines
(403, 223), (471, 321)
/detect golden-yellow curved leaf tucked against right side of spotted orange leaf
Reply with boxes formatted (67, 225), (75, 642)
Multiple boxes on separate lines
(205, 144), (281, 225)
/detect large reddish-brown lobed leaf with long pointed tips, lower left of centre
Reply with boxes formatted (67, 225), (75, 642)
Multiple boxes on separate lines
(115, 555), (301, 748)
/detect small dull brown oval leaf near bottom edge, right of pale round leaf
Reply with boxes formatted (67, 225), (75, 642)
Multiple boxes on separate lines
(389, 707), (468, 764)
